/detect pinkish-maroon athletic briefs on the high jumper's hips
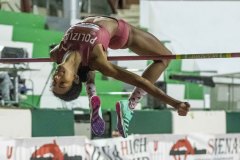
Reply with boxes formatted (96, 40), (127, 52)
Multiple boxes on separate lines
(109, 19), (130, 49)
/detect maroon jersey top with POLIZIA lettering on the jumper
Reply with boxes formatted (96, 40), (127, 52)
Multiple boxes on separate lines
(55, 23), (110, 66)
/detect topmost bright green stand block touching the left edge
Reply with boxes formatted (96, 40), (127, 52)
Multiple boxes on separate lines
(0, 11), (46, 29)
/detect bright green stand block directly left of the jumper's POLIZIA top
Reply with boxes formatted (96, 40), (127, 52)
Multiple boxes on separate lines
(13, 27), (64, 46)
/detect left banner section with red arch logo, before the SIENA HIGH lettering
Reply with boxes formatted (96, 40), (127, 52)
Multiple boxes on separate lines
(0, 137), (86, 160)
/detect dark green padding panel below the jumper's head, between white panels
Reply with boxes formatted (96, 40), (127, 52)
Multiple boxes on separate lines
(32, 109), (74, 137)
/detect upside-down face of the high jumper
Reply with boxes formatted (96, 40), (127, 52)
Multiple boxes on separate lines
(52, 65), (74, 94)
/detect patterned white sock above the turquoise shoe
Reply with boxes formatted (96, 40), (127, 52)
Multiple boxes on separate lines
(128, 87), (147, 109)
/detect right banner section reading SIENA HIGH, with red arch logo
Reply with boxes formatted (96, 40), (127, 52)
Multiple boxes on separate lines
(89, 134), (240, 160)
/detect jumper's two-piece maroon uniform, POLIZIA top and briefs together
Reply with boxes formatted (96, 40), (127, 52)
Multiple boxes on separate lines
(51, 18), (130, 66)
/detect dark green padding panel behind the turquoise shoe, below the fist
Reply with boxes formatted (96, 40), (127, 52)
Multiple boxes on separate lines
(111, 110), (172, 134)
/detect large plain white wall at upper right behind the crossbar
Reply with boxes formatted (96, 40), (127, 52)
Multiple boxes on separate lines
(140, 0), (240, 73)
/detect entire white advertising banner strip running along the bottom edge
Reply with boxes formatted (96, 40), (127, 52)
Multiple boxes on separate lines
(0, 134), (240, 160)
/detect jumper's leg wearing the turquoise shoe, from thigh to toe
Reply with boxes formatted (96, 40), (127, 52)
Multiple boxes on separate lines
(116, 25), (171, 138)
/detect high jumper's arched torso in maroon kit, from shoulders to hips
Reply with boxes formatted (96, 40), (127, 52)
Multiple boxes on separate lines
(51, 17), (128, 82)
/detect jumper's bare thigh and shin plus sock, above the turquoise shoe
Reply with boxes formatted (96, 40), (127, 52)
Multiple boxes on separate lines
(128, 26), (172, 109)
